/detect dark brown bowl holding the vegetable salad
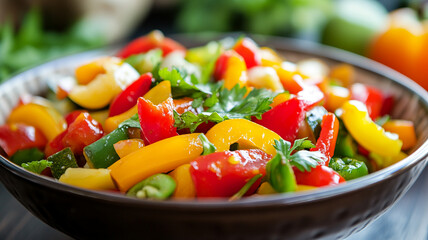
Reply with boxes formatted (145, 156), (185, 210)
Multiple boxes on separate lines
(0, 36), (428, 239)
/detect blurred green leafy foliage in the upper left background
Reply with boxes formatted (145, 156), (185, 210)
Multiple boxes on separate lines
(0, 9), (104, 82)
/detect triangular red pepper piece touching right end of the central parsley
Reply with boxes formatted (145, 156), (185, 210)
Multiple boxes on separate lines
(253, 98), (306, 142)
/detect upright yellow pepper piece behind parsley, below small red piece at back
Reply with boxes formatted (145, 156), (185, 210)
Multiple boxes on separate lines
(224, 54), (248, 89)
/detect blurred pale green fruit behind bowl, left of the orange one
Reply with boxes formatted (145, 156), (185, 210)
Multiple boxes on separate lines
(321, 0), (388, 55)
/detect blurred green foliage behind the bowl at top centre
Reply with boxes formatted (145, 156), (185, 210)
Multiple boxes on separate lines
(177, 0), (334, 40)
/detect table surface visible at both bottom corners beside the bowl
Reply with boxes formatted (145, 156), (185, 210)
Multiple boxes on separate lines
(0, 167), (428, 240)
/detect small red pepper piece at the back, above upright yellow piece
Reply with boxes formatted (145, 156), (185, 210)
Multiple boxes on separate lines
(233, 38), (262, 69)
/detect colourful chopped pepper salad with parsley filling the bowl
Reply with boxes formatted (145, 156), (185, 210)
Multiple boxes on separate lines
(0, 31), (416, 200)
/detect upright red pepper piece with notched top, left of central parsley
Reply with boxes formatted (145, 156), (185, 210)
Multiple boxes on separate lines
(137, 97), (178, 144)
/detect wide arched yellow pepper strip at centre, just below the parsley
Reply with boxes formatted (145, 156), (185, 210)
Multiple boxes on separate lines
(206, 119), (281, 155)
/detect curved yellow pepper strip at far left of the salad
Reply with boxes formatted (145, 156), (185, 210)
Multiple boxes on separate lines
(7, 103), (67, 141)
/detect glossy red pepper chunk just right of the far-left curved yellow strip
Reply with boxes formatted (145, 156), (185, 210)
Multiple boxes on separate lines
(62, 112), (104, 154)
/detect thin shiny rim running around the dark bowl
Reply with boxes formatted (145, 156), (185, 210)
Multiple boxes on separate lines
(0, 33), (428, 211)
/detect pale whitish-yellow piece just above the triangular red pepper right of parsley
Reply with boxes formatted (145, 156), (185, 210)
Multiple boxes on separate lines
(247, 67), (284, 92)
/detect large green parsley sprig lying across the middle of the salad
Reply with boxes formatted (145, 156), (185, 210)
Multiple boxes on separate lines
(174, 84), (276, 132)
